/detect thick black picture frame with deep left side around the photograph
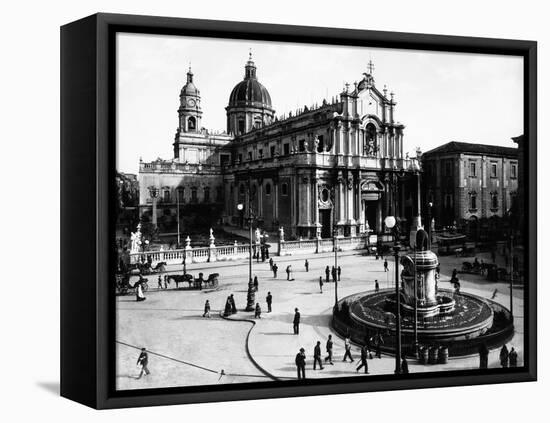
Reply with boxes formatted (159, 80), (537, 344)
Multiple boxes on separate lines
(61, 13), (537, 409)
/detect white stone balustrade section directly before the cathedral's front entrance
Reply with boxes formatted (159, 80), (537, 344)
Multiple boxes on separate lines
(278, 235), (369, 256)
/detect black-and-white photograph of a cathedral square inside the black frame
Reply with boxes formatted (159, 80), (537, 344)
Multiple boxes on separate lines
(113, 32), (529, 391)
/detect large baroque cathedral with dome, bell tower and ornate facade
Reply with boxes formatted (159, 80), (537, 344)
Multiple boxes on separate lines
(139, 53), (420, 238)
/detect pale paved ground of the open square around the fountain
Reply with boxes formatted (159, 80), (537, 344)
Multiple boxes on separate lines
(116, 251), (523, 389)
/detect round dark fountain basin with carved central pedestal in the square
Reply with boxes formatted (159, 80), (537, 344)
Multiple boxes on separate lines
(333, 229), (513, 355)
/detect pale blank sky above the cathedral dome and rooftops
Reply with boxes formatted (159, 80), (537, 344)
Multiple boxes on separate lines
(117, 34), (523, 173)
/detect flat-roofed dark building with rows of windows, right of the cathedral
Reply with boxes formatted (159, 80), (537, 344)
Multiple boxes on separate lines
(422, 141), (519, 235)
